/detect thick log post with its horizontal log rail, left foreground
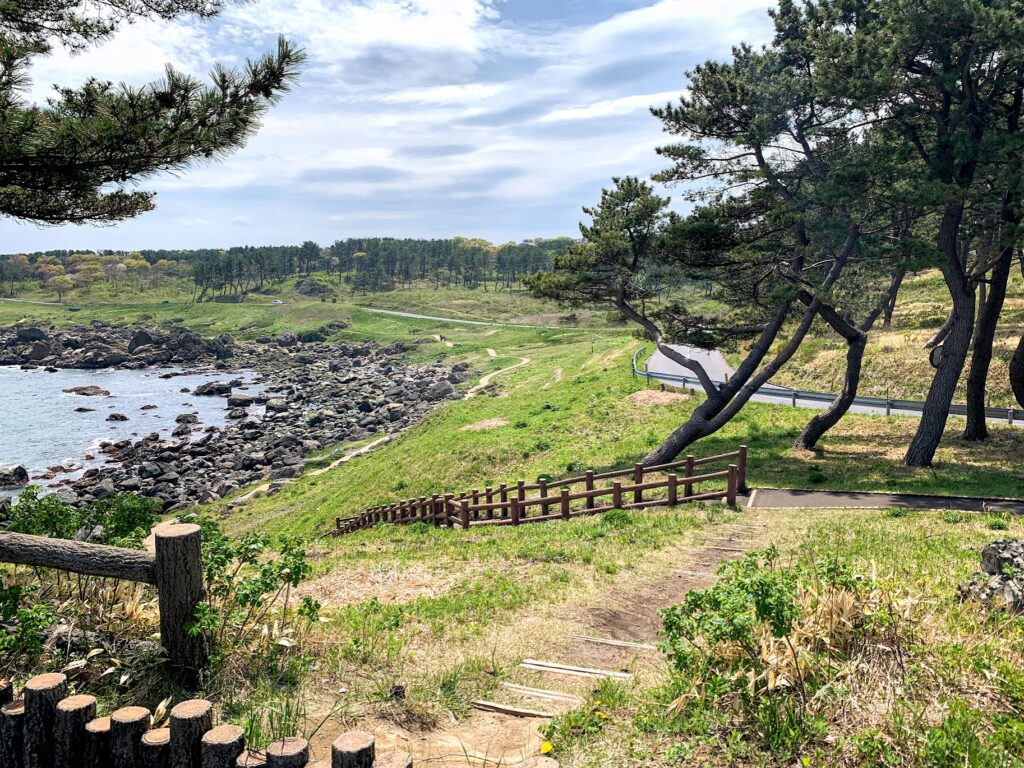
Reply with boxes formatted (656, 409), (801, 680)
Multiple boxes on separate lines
(0, 523), (208, 684)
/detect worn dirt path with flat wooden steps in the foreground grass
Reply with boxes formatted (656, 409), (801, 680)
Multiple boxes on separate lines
(307, 510), (777, 768)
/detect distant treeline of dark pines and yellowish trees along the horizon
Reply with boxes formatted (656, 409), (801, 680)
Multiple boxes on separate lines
(0, 238), (573, 301)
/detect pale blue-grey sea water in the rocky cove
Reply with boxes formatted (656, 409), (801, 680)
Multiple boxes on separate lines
(0, 367), (260, 496)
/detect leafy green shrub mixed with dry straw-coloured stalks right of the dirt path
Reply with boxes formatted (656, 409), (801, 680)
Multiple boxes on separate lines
(663, 549), (905, 761)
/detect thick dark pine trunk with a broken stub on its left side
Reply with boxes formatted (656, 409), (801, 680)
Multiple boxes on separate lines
(903, 203), (975, 467)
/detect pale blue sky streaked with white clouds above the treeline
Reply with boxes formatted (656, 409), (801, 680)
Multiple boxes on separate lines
(0, 0), (771, 253)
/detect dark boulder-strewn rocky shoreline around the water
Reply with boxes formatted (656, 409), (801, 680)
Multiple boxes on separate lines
(0, 322), (470, 512)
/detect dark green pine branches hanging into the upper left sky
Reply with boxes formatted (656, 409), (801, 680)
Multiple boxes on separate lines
(0, 0), (304, 224)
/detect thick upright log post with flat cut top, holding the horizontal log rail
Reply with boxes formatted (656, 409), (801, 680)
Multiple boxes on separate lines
(153, 523), (209, 686)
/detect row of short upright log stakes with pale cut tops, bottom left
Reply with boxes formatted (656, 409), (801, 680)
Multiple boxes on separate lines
(0, 674), (558, 768)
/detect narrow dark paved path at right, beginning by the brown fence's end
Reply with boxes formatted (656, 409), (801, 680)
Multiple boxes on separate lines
(746, 488), (1024, 515)
